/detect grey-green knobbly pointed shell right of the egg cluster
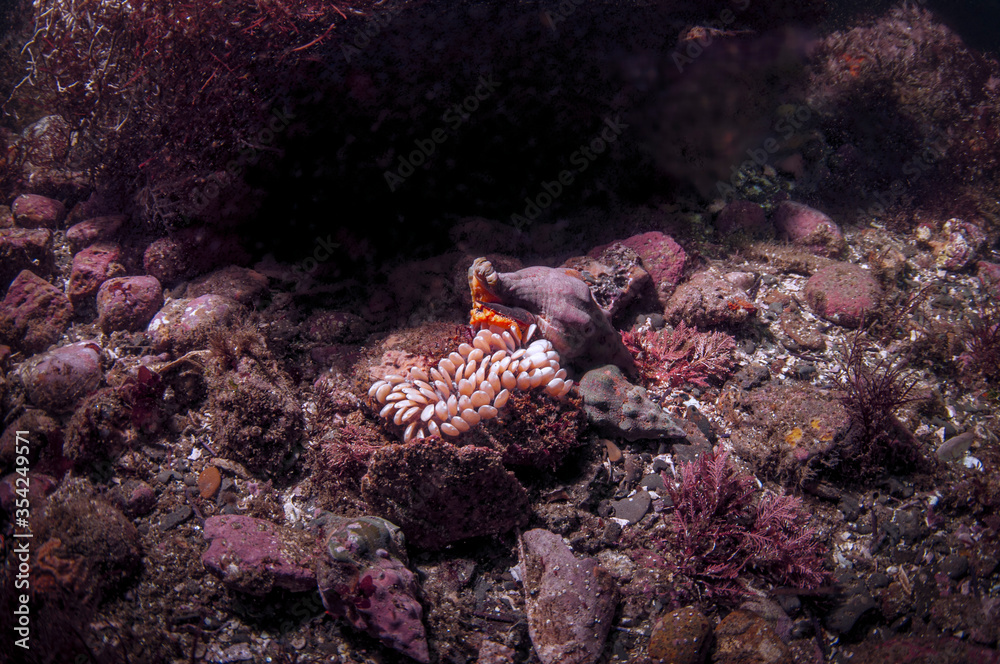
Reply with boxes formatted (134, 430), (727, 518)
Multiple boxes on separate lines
(580, 364), (686, 440)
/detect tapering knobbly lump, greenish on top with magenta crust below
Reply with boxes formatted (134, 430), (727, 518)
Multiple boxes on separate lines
(316, 516), (430, 663)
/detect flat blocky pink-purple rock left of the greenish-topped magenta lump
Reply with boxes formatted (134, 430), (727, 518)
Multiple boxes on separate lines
(201, 514), (316, 596)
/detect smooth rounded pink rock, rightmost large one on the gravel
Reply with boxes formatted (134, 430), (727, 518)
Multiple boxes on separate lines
(805, 263), (882, 328)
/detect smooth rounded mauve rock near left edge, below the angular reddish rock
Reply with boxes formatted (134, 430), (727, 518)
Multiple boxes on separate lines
(21, 341), (103, 412)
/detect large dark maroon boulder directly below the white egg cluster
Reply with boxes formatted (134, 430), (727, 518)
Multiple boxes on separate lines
(361, 440), (529, 549)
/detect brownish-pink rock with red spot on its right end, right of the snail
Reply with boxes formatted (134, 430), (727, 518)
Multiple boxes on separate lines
(664, 270), (756, 328)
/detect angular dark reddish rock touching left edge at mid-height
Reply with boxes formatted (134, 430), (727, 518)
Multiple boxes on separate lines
(0, 270), (73, 353)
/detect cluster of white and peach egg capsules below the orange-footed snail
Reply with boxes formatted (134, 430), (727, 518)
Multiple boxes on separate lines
(368, 330), (573, 442)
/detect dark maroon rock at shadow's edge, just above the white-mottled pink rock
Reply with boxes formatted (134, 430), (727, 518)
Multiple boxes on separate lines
(142, 228), (248, 285)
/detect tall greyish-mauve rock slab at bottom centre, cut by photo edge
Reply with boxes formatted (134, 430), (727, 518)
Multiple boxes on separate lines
(520, 529), (618, 664)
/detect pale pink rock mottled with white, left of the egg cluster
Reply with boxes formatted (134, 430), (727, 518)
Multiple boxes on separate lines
(146, 295), (243, 353)
